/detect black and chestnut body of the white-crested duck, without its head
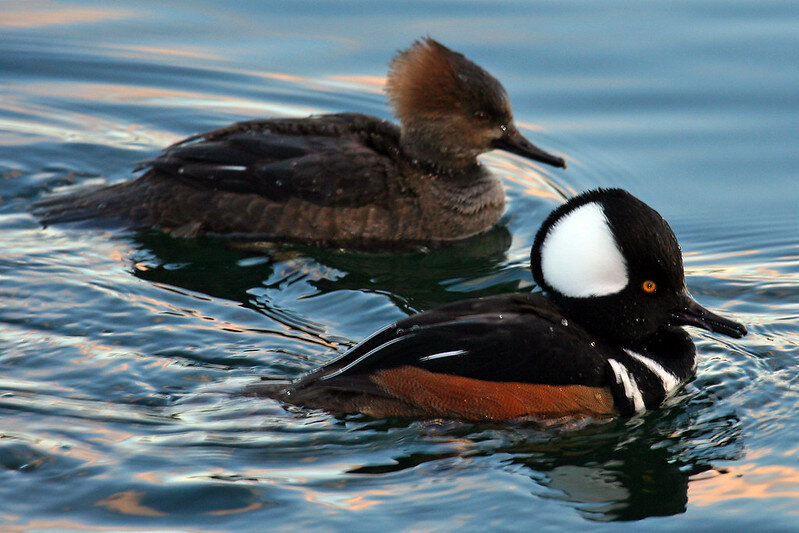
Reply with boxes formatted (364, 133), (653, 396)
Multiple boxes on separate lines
(253, 293), (695, 420)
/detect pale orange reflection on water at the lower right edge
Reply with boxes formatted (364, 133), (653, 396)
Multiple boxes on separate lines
(688, 463), (799, 508)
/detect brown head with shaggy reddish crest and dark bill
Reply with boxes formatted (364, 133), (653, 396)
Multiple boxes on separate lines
(386, 38), (566, 168)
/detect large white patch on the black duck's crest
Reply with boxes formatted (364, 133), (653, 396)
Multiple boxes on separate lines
(541, 202), (629, 298)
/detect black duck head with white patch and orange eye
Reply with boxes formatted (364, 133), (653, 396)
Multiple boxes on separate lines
(531, 189), (746, 343)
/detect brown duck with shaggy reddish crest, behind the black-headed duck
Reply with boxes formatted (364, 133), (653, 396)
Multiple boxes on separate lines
(32, 38), (566, 245)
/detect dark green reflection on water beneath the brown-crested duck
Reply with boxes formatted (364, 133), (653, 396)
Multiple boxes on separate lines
(126, 222), (512, 315)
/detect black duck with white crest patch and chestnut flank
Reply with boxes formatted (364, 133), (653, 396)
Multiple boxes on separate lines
(256, 189), (746, 420)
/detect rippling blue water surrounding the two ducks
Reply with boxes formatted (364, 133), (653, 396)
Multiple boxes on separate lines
(0, 0), (799, 531)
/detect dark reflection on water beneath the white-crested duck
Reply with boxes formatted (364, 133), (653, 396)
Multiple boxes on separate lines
(350, 402), (743, 522)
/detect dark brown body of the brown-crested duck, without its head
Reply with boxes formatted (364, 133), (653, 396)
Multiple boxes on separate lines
(37, 113), (504, 243)
